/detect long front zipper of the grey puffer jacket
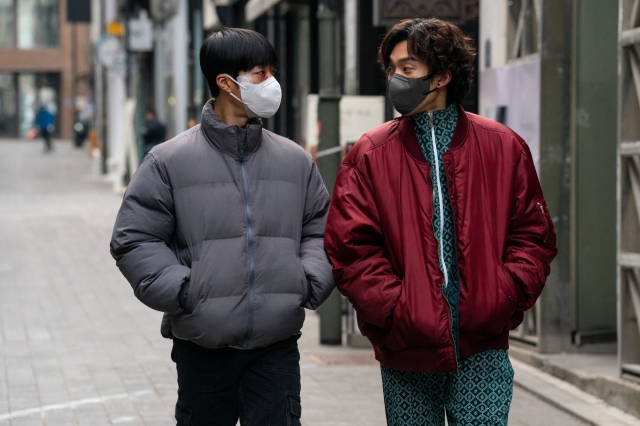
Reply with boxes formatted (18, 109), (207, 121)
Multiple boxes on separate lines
(236, 128), (256, 348)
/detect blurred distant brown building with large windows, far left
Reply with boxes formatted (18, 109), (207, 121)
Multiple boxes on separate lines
(0, 0), (89, 138)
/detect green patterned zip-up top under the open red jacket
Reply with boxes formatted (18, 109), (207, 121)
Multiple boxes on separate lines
(413, 103), (460, 356)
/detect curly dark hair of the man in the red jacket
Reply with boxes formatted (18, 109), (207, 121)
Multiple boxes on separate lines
(378, 18), (476, 105)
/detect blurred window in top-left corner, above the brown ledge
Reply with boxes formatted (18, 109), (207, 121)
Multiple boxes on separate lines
(0, 0), (60, 49)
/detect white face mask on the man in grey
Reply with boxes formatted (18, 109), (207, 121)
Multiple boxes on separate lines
(225, 74), (282, 118)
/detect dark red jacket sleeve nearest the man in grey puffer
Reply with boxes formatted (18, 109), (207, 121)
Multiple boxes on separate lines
(325, 164), (402, 333)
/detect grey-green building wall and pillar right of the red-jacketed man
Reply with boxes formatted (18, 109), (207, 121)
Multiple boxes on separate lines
(479, 0), (619, 353)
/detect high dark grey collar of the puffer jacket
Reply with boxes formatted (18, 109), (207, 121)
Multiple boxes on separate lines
(201, 99), (262, 160)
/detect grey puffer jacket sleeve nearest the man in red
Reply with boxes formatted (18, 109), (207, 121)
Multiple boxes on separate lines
(300, 163), (336, 309)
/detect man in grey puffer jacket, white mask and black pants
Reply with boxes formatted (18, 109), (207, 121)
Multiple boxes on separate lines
(111, 28), (335, 426)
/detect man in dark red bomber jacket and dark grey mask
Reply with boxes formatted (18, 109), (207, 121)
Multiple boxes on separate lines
(325, 19), (557, 426)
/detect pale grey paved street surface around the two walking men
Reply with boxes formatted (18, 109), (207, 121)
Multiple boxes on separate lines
(0, 140), (586, 426)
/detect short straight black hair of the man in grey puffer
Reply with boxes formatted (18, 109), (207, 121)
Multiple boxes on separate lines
(200, 28), (278, 98)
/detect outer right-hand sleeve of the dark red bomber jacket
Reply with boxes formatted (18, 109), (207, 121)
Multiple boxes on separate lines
(504, 140), (558, 314)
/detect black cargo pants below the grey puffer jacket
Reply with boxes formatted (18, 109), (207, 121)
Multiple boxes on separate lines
(171, 335), (301, 426)
